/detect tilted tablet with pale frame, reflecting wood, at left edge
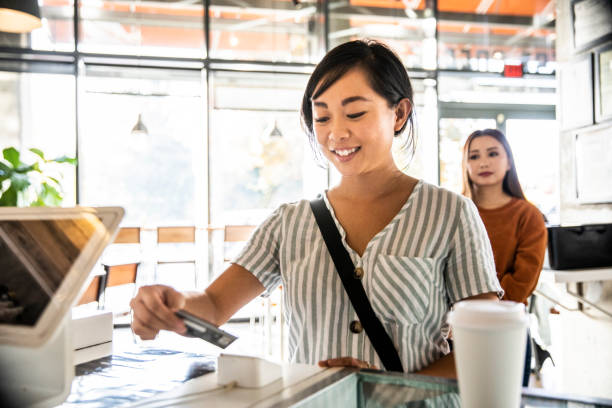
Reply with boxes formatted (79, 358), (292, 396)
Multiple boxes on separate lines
(0, 207), (123, 346)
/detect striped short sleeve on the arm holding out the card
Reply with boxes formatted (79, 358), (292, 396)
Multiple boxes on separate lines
(232, 206), (283, 293)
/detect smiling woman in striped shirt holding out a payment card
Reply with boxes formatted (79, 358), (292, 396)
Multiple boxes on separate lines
(131, 41), (502, 377)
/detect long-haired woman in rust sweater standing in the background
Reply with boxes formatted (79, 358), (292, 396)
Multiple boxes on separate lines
(462, 129), (546, 386)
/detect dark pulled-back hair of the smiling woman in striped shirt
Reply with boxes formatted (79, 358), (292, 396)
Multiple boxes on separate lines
(301, 40), (415, 163)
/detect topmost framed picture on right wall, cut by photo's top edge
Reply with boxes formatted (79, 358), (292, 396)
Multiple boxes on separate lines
(571, 0), (612, 51)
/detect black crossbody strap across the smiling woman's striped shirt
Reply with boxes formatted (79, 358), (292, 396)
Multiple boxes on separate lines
(310, 198), (404, 372)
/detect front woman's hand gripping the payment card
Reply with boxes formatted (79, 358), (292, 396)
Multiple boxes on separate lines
(130, 285), (187, 340)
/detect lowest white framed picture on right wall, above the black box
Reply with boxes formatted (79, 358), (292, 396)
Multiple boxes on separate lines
(575, 125), (612, 204)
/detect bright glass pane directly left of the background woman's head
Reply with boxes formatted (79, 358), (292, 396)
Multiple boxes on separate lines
(440, 118), (496, 193)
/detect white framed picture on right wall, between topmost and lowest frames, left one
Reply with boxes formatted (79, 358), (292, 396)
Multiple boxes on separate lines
(559, 54), (593, 130)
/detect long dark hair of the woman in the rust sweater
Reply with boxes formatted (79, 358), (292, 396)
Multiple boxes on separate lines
(461, 129), (525, 200)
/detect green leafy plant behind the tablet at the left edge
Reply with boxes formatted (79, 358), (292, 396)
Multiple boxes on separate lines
(0, 147), (76, 207)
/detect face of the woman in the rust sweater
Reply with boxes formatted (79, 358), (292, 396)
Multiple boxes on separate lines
(466, 136), (510, 186)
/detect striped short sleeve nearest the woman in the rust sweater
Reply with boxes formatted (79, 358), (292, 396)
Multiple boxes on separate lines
(444, 197), (504, 303)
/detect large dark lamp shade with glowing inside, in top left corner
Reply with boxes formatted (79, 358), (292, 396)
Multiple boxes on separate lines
(0, 0), (42, 34)
